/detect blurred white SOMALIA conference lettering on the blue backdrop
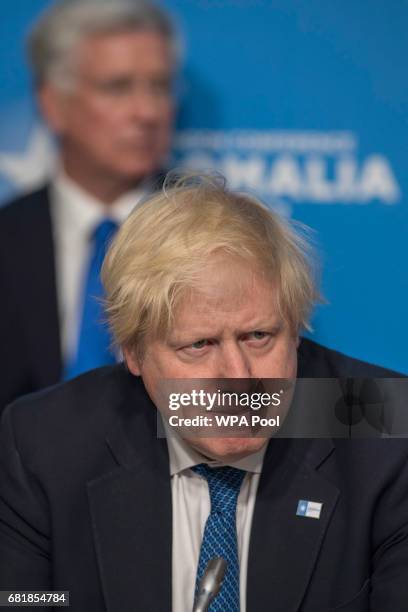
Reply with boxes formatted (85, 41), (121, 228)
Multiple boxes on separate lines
(171, 130), (401, 215)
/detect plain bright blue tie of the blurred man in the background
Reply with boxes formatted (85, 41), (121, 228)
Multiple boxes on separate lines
(64, 219), (118, 380)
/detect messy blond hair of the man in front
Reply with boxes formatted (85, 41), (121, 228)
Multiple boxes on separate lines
(102, 173), (318, 351)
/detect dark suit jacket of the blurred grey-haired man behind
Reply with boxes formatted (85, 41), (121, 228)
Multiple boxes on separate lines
(0, 177), (165, 414)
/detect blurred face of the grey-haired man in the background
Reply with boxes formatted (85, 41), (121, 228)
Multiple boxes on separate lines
(40, 31), (173, 181)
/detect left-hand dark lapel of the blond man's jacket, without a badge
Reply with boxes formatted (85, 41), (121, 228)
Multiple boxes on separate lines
(88, 382), (172, 612)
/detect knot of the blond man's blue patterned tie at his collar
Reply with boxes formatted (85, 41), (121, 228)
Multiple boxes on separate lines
(191, 463), (246, 514)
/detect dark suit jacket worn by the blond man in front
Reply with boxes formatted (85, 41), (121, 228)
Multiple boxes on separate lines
(0, 341), (408, 612)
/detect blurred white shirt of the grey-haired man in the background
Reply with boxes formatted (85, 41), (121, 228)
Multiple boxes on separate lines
(50, 169), (147, 362)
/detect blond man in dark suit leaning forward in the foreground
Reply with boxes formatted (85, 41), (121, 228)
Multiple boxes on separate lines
(0, 177), (408, 612)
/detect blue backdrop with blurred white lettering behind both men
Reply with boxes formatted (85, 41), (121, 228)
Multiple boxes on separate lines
(0, 0), (408, 372)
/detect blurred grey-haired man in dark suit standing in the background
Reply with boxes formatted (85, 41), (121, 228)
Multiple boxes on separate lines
(0, 0), (177, 411)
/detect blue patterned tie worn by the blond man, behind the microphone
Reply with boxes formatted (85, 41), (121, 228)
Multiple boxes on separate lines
(192, 463), (246, 612)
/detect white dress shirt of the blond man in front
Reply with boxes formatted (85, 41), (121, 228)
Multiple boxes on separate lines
(167, 432), (267, 612)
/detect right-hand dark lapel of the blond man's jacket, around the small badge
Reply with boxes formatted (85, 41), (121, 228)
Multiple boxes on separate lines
(247, 439), (339, 612)
